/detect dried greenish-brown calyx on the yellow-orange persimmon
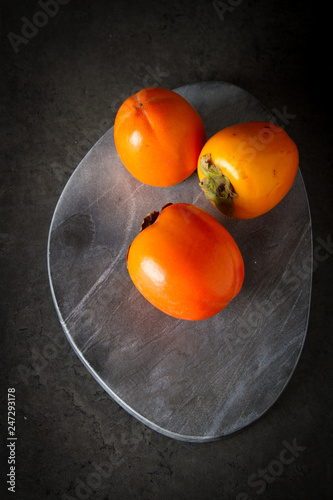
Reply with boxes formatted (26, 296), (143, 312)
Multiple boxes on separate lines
(199, 154), (238, 217)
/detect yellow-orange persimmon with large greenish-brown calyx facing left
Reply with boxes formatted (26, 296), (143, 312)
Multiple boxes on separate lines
(198, 121), (299, 219)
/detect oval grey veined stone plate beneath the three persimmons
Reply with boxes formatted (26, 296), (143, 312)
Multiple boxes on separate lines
(48, 82), (312, 442)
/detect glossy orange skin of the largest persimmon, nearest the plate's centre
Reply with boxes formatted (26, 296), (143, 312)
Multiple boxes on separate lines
(127, 203), (244, 321)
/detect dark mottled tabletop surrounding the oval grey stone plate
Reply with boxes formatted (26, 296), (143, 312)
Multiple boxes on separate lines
(0, 0), (333, 500)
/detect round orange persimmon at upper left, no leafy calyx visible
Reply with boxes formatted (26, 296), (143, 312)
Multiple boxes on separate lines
(114, 87), (206, 187)
